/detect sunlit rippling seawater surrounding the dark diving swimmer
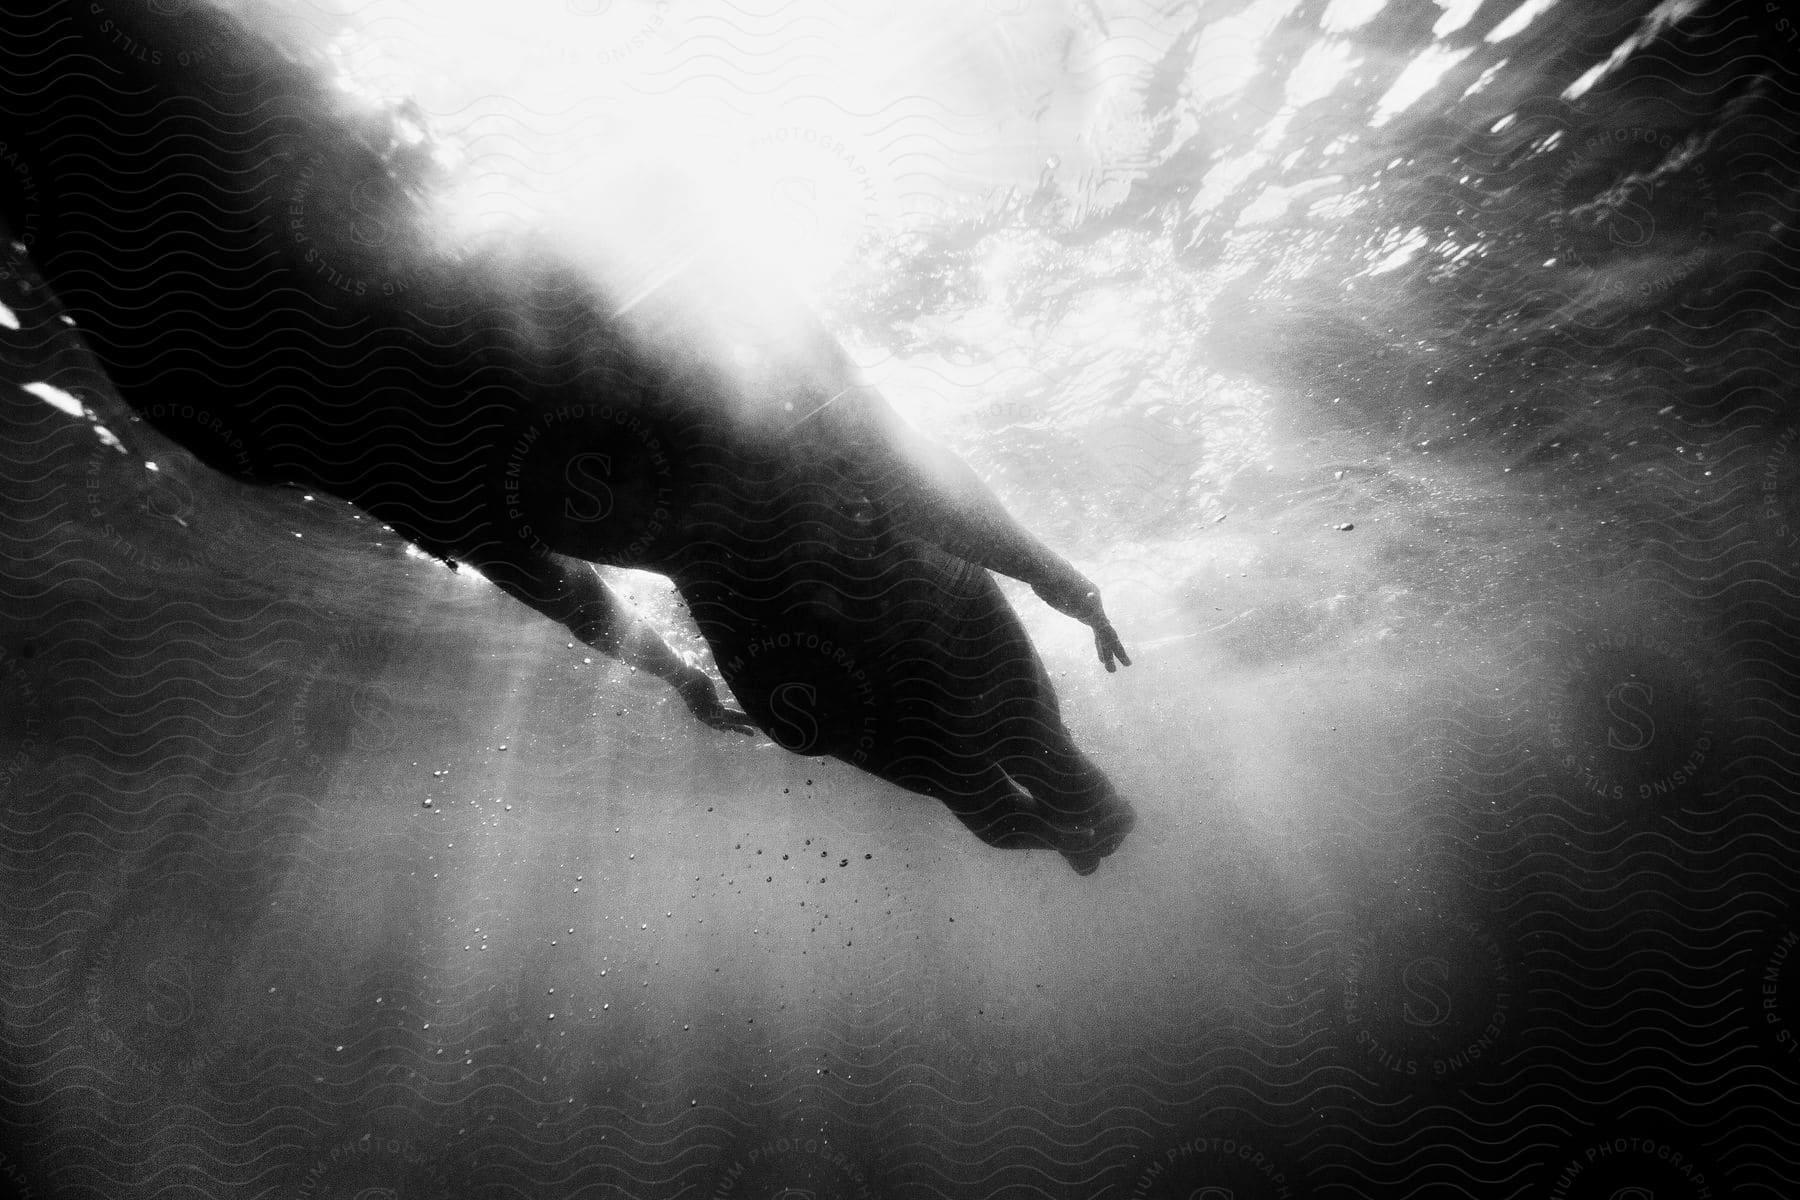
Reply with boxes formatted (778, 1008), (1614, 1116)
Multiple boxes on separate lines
(0, 0), (1800, 1200)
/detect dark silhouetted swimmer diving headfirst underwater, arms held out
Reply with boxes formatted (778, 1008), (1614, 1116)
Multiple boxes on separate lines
(0, 2), (1132, 874)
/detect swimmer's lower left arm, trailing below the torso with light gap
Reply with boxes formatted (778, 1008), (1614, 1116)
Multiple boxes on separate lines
(468, 549), (756, 734)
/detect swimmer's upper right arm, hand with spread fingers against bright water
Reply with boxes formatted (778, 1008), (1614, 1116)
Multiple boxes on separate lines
(826, 385), (1130, 671)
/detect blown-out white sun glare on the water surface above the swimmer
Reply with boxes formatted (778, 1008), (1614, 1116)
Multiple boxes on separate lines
(307, 0), (925, 309)
